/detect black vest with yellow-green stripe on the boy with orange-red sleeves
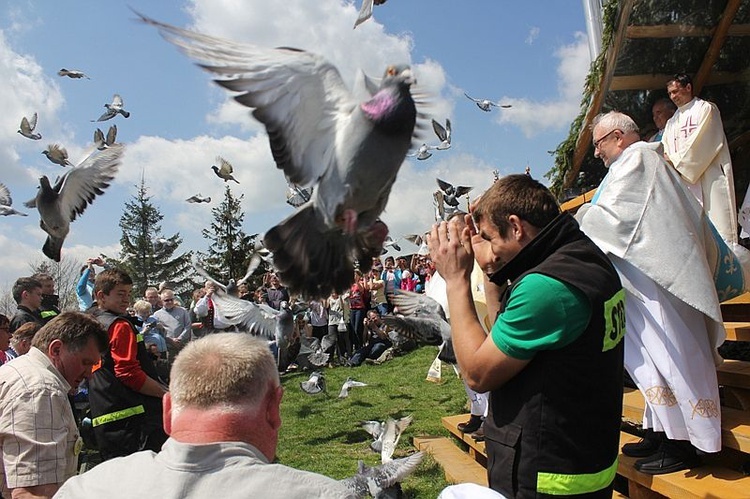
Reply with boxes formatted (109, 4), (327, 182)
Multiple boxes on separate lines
(89, 308), (166, 459)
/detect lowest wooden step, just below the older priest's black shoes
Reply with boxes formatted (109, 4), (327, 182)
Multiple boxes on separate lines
(617, 432), (750, 499)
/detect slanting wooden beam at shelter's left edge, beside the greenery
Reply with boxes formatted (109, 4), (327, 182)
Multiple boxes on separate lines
(563, 0), (636, 188)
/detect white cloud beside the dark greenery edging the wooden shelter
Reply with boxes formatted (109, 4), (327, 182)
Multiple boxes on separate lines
(497, 32), (590, 137)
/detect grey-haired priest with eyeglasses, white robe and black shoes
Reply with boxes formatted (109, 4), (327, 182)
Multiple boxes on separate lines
(577, 111), (745, 475)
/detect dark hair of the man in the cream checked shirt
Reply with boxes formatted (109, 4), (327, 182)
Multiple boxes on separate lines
(31, 312), (109, 353)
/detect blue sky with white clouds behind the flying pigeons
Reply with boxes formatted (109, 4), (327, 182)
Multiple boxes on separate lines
(0, 0), (600, 289)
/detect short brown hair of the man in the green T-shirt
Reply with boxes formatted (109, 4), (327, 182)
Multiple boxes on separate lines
(472, 174), (560, 237)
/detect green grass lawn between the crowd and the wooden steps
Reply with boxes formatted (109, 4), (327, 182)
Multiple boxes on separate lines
(277, 347), (466, 498)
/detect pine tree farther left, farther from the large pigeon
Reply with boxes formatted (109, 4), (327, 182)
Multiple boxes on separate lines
(109, 176), (194, 297)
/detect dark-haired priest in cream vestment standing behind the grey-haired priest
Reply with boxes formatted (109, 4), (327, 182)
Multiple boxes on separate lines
(661, 74), (738, 244)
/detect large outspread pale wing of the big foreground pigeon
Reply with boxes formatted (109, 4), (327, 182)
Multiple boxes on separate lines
(141, 16), (356, 190)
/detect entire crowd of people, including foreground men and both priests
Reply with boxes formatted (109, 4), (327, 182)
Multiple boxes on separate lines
(0, 75), (750, 497)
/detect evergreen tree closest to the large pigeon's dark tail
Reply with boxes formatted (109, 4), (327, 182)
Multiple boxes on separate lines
(199, 185), (257, 283)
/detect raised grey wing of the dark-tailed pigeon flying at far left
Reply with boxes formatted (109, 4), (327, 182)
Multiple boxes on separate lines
(54, 146), (124, 221)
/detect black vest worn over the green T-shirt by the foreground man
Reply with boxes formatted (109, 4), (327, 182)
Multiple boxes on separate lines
(485, 214), (625, 498)
